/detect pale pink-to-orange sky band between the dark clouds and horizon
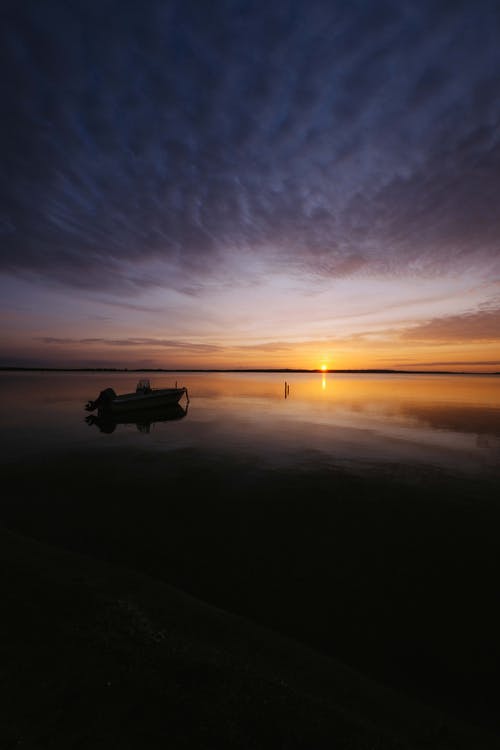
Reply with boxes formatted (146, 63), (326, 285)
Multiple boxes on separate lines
(0, 277), (500, 372)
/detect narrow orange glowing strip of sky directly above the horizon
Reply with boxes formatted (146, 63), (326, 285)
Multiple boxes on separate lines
(2, 322), (500, 373)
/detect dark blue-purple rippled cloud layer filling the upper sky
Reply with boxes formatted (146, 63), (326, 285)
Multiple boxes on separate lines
(0, 0), (500, 290)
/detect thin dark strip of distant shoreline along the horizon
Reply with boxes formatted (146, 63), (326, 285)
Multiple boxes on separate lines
(0, 367), (500, 375)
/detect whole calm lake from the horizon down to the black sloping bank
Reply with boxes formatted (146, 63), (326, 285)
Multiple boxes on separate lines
(0, 372), (500, 728)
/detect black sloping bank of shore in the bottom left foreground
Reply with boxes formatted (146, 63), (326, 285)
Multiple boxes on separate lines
(0, 532), (486, 749)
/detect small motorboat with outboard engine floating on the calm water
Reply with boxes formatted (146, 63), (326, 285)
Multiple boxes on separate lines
(85, 379), (189, 414)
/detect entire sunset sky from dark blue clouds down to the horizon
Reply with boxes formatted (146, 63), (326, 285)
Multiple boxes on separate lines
(0, 0), (500, 371)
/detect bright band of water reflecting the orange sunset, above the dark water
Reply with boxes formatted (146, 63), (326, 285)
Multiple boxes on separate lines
(0, 373), (500, 471)
